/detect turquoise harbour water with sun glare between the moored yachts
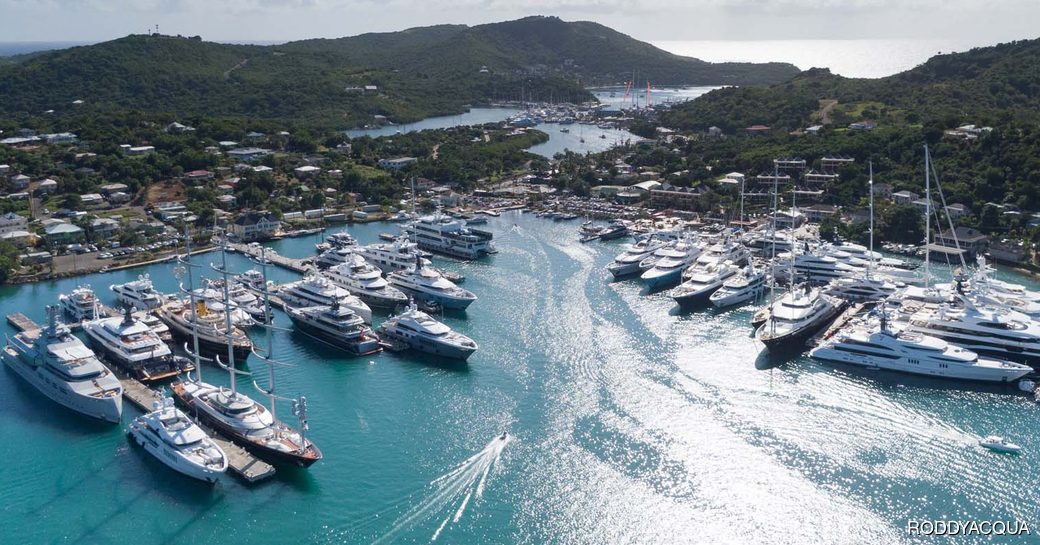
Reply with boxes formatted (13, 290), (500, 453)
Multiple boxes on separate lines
(0, 213), (1040, 545)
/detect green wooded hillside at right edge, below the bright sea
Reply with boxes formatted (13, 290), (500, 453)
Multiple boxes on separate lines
(664, 40), (1040, 131)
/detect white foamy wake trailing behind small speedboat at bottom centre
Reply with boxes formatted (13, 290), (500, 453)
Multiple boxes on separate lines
(372, 434), (513, 545)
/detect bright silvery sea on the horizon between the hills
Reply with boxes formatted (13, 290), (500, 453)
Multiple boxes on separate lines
(651, 40), (992, 78)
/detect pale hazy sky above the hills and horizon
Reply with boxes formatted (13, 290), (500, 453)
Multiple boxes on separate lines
(0, 0), (1040, 45)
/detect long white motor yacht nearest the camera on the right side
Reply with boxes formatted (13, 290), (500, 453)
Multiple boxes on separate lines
(809, 308), (1033, 382)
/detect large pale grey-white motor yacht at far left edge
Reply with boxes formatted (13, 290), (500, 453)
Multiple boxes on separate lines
(2, 307), (123, 422)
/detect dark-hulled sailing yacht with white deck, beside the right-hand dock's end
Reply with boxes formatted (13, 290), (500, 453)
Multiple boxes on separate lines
(755, 285), (844, 351)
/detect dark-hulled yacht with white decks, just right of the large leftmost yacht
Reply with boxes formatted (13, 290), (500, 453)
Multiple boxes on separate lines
(83, 308), (194, 383)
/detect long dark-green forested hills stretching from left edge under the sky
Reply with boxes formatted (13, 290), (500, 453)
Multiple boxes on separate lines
(0, 18), (797, 127)
